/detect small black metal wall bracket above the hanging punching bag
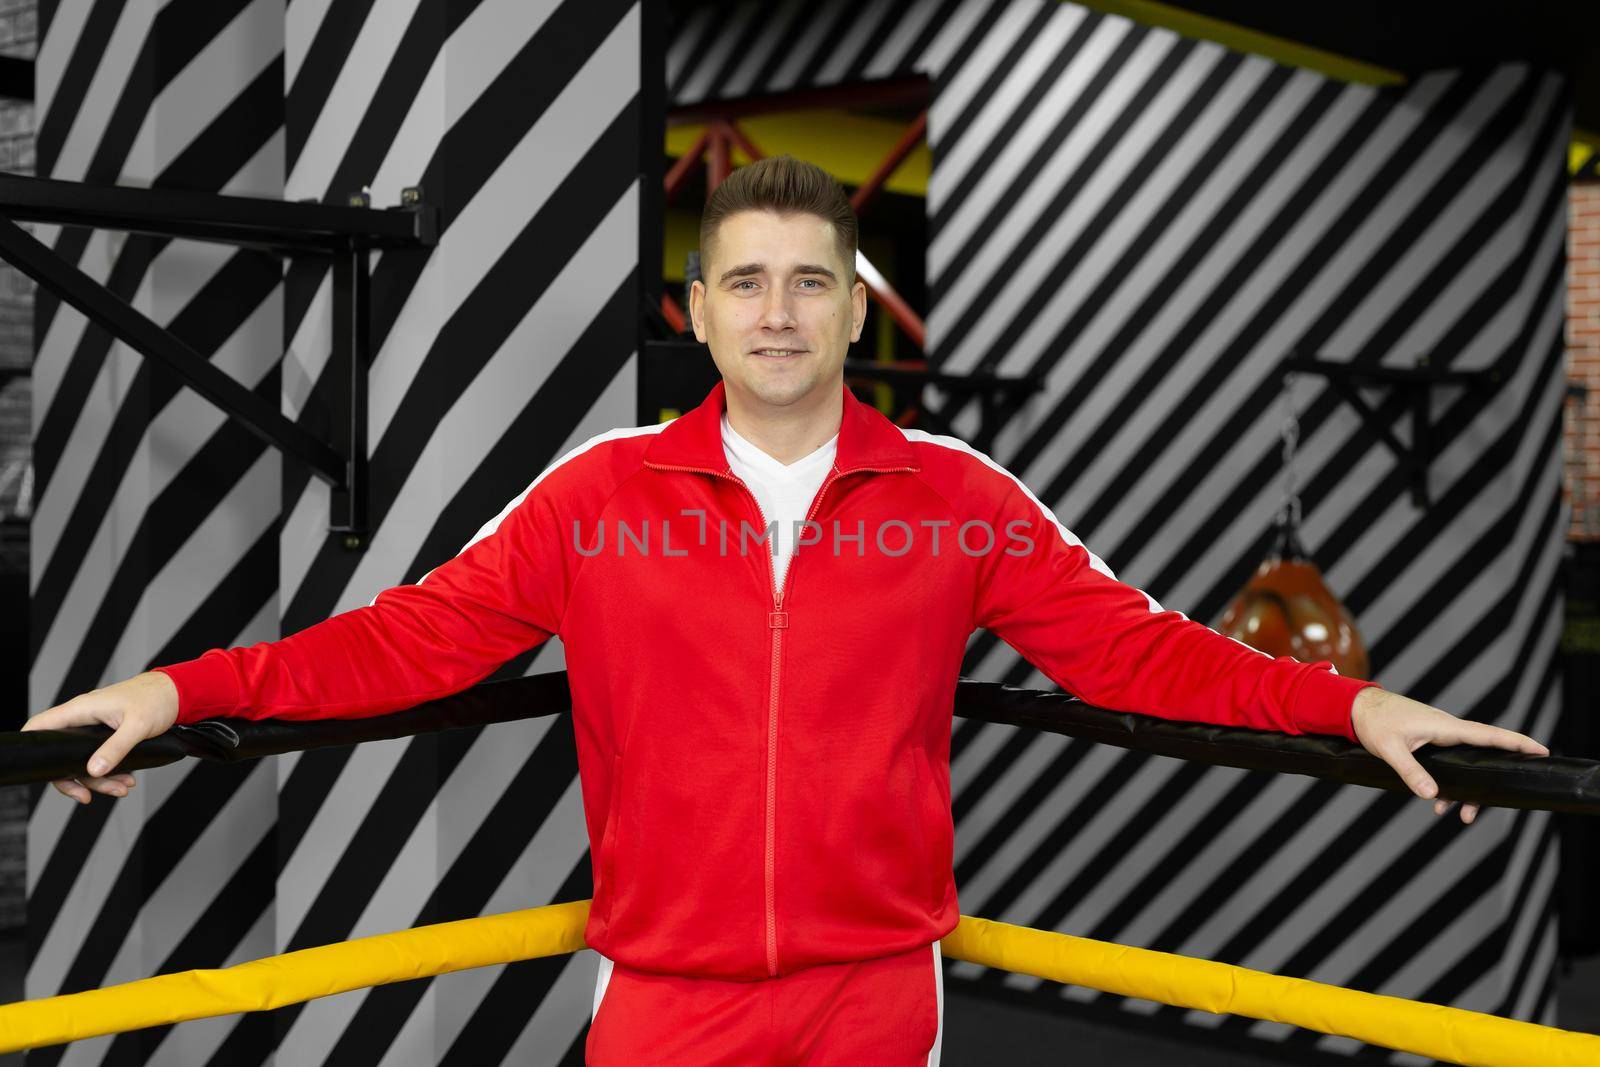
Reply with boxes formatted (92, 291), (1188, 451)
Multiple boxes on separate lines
(1282, 355), (1502, 509)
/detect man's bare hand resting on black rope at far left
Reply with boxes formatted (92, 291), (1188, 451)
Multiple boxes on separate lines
(22, 670), (178, 805)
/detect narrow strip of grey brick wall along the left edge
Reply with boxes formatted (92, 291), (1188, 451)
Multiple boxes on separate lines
(0, 0), (35, 931)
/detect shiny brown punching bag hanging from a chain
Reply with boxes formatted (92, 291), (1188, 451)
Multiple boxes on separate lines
(1216, 518), (1368, 680)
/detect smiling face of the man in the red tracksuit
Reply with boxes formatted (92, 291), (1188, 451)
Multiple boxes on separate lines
(690, 211), (867, 408)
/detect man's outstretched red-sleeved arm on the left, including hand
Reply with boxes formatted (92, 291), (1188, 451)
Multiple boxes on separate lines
(22, 451), (592, 803)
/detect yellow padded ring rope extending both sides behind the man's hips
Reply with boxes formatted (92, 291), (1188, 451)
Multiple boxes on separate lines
(0, 901), (1600, 1067)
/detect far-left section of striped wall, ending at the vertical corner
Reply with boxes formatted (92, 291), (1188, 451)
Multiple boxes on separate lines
(26, 0), (283, 1064)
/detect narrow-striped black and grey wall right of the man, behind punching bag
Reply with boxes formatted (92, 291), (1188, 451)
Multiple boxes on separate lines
(669, 0), (1570, 1062)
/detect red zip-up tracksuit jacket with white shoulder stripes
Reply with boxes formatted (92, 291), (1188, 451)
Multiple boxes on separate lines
(160, 384), (1371, 979)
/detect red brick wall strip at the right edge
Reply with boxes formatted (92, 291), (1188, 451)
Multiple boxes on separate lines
(1566, 181), (1600, 541)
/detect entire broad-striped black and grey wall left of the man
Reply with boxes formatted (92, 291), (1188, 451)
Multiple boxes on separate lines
(27, 0), (649, 1065)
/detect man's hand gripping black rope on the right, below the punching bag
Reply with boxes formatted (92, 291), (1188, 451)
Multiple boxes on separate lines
(1350, 686), (1550, 822)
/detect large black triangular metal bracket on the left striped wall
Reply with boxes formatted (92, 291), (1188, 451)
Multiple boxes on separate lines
(0, 174), (438, 549)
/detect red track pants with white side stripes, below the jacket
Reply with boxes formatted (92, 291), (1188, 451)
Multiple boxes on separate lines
(584, 942), (944, 1067)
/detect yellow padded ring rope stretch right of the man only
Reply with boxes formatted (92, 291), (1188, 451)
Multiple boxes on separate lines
(941, 915), (1600, 1067)
